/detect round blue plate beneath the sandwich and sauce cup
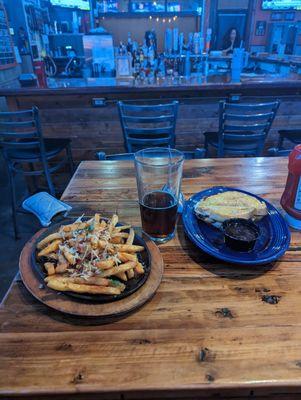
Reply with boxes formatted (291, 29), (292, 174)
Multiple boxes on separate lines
(182, 186), (290, 265)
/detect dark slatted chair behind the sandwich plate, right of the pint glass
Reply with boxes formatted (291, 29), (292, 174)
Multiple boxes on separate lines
(205, 100), (280, 157)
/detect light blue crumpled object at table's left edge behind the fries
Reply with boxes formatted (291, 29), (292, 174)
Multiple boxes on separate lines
(22, 192), (72, 226)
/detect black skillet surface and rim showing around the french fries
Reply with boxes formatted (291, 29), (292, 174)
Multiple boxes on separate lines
(31, 218), (151, 303)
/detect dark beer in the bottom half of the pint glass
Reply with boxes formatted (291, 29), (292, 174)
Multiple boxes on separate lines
(140, 191), (178, 239)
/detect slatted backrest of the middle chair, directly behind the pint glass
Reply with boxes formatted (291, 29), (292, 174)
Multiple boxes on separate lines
(118, 101), (179, 152)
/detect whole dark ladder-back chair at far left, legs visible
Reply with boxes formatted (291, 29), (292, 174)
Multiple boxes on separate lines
(0, 107), (74, 238)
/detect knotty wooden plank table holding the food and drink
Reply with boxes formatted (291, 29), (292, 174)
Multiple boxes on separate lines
(0, 158), (301, 400)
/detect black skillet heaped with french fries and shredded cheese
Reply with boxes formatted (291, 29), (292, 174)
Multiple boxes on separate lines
(32, 214), (151, 303)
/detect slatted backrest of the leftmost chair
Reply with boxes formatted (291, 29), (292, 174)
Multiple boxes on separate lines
(0, 107), (44, 154)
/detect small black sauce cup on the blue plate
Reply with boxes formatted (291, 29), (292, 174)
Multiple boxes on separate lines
(222, 218), (260, 252)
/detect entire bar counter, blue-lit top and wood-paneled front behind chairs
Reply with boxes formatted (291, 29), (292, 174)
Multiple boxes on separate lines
(0, 74), (301, 161)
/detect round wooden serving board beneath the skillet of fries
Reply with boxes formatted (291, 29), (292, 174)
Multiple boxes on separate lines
(19, 229), (164, 323)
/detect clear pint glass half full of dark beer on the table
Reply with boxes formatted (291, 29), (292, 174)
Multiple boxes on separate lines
(135, 147), (184, 243)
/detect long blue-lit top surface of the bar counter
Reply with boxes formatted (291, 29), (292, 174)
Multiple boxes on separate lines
(0, 73), (301, 99)
